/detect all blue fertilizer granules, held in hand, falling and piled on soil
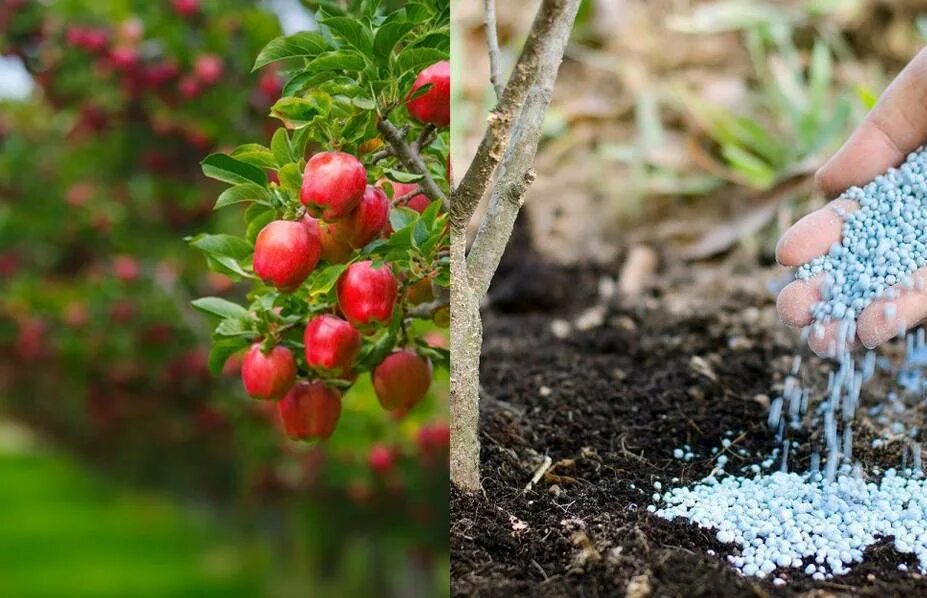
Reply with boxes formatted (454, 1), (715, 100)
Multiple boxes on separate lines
(648, 148), (927, 584)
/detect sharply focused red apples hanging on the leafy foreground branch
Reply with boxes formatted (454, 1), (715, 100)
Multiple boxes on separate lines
(241, 61), (450, 442)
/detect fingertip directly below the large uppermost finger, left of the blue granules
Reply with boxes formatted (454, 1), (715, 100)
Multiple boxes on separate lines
(776, 199), (859, 266)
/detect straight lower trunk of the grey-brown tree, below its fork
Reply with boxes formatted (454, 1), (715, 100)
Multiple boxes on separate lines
(450, 226), (483, 492)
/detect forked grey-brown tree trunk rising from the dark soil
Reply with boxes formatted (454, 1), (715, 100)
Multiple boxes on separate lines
(450, 0), (580, 492)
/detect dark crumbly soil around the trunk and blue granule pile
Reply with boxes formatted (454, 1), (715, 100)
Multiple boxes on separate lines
(451, 237), (927, 598)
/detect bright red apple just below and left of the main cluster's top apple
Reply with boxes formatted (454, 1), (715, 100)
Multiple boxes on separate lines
(254, 220), (322, 291)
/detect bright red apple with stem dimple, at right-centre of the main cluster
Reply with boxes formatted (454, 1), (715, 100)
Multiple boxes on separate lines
(336, 260), (399, 328)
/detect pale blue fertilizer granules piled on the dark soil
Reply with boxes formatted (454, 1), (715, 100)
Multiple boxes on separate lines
(655, 469), (927, 579)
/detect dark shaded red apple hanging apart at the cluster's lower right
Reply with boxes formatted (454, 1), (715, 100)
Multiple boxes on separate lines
(371, 349), (431, 411)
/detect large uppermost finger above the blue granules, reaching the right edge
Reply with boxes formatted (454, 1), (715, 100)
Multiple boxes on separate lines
(815, 50), (927, 196)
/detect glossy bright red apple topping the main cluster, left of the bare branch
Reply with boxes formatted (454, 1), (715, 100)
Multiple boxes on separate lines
(299, 152), (367, 221)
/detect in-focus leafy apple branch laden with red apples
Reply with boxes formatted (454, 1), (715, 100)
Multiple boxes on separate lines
(188, 0), (450, 446)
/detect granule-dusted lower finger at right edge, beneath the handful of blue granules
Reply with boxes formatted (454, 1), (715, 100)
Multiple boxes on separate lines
(856, 268), (927, 349)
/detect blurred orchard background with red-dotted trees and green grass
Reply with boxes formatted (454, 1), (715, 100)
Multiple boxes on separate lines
(0, 0), (448, 596)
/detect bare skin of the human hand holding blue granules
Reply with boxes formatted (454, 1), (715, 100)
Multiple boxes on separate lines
(776, 50), (927, 356)
